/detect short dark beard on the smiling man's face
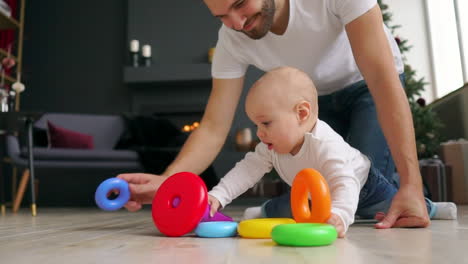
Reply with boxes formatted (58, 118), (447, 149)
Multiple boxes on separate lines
(240, 0), (276, 39)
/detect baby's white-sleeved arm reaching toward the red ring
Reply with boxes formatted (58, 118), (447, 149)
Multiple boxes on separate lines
(208, 143), (272, 214)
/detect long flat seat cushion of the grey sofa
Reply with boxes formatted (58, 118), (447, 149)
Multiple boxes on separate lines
(21, 148), (138, 162)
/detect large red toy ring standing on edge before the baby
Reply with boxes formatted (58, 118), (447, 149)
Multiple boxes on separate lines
(152, 172), (208, 237)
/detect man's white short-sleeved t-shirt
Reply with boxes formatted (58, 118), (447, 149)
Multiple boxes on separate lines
(211, 0), (403, 95)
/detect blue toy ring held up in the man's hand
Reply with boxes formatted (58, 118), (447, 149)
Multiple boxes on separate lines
(94, 178), (130, 211)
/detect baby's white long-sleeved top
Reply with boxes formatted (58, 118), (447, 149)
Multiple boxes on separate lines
(209, 120), (370, 230)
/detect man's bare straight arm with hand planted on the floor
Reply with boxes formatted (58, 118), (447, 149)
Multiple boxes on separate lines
(346, 5), (430, 228)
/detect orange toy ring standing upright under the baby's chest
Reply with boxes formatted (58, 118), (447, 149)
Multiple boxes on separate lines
(291, 169), (331, 223)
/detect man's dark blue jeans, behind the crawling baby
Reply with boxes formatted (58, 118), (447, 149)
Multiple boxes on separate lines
(263, 74), (429, 217)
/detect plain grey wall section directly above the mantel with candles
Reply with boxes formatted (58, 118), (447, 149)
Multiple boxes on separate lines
(127, 0), (221, 63)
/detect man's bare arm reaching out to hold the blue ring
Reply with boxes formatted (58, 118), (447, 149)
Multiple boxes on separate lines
(117, 77), (244, 211)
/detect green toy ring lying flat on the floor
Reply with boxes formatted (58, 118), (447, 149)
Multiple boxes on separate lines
(271, 223), (338, 247)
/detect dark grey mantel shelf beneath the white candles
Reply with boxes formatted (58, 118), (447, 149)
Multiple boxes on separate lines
(124, 63), (211, 84)
